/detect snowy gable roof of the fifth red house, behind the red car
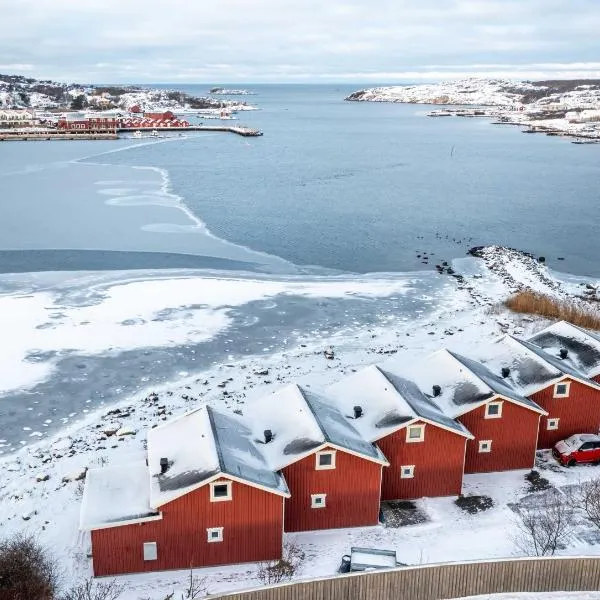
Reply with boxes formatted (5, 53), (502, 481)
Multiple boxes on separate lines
(481, 335), (600, 396)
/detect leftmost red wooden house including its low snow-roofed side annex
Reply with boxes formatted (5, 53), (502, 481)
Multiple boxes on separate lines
(81, 408), (289, 576)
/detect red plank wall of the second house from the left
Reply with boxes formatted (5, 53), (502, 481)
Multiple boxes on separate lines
(283, 450), (382, 531)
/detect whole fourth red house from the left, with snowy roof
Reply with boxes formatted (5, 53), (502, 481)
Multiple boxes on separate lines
(411, 350), (546, 473)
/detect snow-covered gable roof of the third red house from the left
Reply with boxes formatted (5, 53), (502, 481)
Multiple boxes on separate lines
(327, 365), (470, 442)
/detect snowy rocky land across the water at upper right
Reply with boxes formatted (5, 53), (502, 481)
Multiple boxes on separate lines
(346, 78), (600, 143)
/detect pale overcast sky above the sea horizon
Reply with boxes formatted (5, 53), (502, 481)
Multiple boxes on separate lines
(0, 0), (600, 83)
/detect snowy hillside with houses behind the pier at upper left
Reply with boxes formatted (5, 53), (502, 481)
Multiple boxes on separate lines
(0, 74), (252, 112)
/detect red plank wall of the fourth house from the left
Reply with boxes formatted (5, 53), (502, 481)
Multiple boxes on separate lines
(458, 400), (540, 473)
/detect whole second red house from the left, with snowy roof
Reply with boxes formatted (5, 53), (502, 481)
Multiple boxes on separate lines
(248, 385), (388, 531)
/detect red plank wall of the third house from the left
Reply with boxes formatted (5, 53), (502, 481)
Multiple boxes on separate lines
(377, 423), (467, 500)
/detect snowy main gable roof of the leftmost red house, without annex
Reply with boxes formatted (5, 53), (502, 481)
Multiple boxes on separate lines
(148, 406), (289, 507)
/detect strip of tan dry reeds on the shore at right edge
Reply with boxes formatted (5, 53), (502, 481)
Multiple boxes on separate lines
(504, 290), (600, 330)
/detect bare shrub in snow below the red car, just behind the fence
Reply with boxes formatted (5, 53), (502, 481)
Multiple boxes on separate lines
(514, 490), (575, 556)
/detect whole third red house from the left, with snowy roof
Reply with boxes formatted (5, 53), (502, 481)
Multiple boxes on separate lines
(328, 366), (473, 500)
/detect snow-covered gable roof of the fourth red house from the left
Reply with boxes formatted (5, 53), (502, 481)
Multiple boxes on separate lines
(409, 349), (545, 418)
